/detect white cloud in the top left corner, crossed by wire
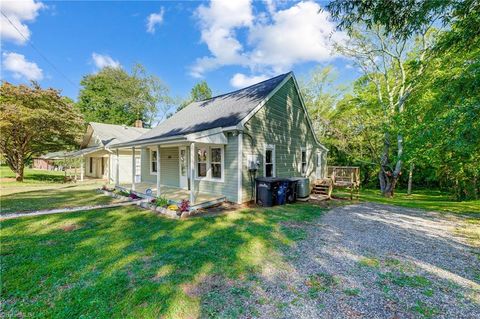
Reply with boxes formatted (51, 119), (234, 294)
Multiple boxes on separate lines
(0, 0), (45, 44)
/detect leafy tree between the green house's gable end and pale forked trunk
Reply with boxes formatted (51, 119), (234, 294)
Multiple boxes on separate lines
(300, 66), (381, 184)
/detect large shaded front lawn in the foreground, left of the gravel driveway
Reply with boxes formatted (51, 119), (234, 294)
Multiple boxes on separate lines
(0, 204), (322, 318)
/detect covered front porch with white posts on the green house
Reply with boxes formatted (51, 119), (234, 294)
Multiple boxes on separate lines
(113, 127), (232, 209)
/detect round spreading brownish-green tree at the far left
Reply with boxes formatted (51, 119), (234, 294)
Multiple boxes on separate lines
(0, 82), (82, 182)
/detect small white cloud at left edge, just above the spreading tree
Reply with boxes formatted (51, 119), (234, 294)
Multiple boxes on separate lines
(2, 52), (43, 81)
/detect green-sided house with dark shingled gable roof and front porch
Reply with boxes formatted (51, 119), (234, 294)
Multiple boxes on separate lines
(111, 72), (328, 208)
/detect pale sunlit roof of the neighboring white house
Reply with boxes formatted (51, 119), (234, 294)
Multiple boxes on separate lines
(84, 122), (150, 147)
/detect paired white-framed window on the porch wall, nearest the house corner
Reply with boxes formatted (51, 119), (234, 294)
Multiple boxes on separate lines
(196, 146), (224, 181)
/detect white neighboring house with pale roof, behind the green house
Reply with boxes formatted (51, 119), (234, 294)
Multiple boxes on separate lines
(68, 121), (149, 182)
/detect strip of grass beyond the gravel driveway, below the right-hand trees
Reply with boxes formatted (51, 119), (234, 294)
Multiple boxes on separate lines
(333, 189), (480, 217)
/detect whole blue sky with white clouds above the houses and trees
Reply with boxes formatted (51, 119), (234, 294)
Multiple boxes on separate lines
(0, 0), (358, 100)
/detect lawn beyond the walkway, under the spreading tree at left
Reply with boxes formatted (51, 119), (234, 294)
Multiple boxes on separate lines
(0, 166), (114, 214)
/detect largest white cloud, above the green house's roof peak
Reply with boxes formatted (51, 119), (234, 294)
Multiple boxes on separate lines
(191, 0), (346, 76)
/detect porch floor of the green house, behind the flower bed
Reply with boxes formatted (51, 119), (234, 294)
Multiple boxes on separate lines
(119, 182), (225, 207)
